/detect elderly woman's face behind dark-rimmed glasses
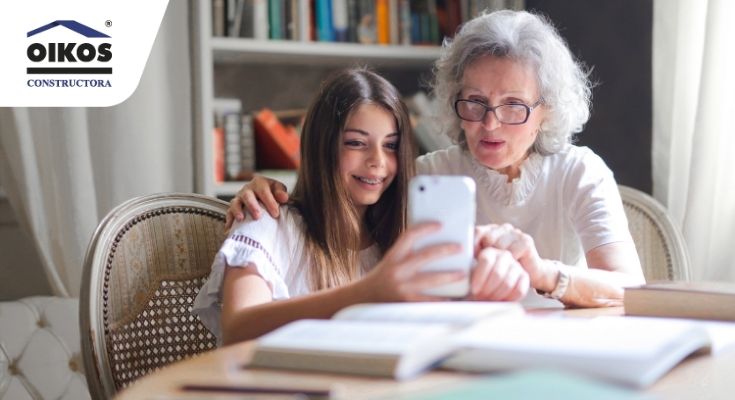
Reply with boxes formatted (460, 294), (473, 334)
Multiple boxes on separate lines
(458, 56), (546, 181)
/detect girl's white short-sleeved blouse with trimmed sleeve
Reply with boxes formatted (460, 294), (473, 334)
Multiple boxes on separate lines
(192, 206), (380, 343)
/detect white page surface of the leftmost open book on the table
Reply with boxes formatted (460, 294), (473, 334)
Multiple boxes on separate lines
(257, 320), (450, 355)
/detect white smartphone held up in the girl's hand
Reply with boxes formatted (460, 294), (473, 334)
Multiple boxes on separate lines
(408, 175), (475, 297)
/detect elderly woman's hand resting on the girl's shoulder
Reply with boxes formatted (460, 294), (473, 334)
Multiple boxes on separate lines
(225, 175), (288, 230)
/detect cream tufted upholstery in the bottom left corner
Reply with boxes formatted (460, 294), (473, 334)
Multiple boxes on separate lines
(0, 297), (89, 400)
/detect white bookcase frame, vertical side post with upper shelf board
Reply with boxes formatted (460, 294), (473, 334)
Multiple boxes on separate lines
(191, 0), (440, 196)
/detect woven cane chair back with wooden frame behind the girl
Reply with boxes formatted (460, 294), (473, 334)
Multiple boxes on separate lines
(80, 193), (228, 398)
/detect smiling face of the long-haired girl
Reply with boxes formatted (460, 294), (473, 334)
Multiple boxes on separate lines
(339, 104), (400, 215)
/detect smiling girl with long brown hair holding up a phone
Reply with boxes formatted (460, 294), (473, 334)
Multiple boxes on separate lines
(193, 69), (527, 343)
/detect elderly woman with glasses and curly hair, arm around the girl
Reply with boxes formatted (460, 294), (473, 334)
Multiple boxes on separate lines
(230, 10), (644, 307)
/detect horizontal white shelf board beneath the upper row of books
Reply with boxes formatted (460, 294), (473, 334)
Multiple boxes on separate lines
(211, 37), (439, 67)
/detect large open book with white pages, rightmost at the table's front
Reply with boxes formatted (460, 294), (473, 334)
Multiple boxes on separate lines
(443, 316), (711, 388)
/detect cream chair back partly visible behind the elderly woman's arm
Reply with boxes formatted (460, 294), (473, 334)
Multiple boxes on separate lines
(618, 185), (689, 281)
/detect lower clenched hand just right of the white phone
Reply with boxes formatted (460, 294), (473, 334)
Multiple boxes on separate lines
(469, 247), (529, 301)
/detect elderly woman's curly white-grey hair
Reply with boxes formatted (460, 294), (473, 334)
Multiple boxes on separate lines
(432, 10), (592, 155)
